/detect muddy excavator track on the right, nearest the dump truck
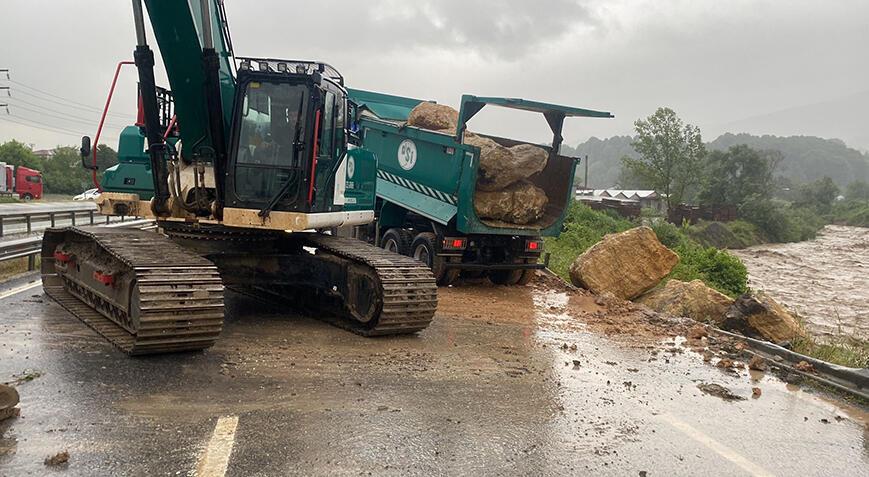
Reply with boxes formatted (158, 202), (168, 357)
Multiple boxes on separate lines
(161, 222), (437, 336)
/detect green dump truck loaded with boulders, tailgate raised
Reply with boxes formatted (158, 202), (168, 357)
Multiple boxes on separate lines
(347, 89), (613, 285)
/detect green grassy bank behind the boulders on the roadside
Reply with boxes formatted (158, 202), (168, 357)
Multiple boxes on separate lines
(546, 202), (748, 297)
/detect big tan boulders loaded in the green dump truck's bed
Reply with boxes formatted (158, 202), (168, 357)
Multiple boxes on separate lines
(407, 102), (549, 225)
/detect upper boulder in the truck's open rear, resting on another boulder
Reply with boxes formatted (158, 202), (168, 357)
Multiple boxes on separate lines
(465, 132), (549, 192)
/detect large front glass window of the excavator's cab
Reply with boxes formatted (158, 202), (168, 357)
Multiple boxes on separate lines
(234, 81), (310, 202)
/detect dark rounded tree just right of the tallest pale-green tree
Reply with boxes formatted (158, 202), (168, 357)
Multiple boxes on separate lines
(698, 144), (782, 207)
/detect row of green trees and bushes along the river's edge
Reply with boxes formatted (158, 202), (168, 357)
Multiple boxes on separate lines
(621, 108), (869, 241)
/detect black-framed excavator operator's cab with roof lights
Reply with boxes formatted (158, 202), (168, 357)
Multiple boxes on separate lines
(224, 58), (347, 217)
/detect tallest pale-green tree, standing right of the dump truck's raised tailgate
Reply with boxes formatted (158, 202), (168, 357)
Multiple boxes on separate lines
(622, 108), (706, 208)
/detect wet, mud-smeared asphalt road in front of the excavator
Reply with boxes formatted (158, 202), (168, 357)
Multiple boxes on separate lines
(0, 276), (869, 476)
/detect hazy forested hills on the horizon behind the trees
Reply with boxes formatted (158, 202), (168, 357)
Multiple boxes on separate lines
(562, 133), (869, 189)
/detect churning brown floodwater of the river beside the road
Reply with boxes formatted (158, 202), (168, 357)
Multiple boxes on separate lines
(733, 225), (869, 339)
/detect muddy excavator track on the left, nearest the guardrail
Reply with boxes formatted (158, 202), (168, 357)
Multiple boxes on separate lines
(42, 227), (224, 355)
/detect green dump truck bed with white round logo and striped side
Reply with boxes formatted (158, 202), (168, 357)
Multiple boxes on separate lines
(350, 89), (592, 236)
